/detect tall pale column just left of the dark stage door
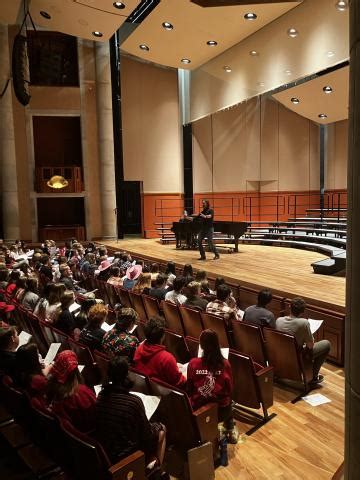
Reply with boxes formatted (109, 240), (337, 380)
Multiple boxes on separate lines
(95, 42), (116, 238)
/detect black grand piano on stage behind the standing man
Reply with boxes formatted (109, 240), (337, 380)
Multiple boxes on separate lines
(171, 217), (247, 252)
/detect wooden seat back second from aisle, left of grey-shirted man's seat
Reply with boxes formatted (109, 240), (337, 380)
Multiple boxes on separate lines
(231, 320), (266, 365)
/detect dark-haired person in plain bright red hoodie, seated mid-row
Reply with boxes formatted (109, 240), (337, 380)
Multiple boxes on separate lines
(134, 316), (186, 388)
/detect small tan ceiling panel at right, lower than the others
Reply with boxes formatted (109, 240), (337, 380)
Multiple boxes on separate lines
(273, 67), (349, 124)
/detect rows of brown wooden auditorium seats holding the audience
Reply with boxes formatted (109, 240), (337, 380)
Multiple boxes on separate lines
(0, 246), (344, 480)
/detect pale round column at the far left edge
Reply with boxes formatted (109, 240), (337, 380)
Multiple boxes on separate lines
(0, 24), (20, 241)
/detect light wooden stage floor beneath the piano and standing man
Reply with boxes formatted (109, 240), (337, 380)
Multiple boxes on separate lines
(105, 238), (345, 307)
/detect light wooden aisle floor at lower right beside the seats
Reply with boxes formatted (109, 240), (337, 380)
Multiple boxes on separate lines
(216, 364), (344, 480)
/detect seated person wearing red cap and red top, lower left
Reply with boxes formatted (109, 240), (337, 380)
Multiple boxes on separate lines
(46, 350), (96, 433)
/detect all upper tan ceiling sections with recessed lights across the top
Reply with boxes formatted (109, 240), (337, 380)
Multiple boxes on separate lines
(0, 0), (302, 69)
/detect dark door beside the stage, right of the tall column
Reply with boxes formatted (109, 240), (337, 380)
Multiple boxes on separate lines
(118, 181), (142, 238)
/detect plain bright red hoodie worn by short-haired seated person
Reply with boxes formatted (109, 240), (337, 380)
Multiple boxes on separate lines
(134, 340), (186, 387)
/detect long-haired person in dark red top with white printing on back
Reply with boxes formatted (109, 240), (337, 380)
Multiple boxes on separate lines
(187, 329), (239, 443)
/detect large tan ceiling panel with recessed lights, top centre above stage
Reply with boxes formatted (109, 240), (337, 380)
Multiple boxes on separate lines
(122, 0), (299, 69)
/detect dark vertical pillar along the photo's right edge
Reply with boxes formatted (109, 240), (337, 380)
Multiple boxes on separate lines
(345, 0), (360, 480)
